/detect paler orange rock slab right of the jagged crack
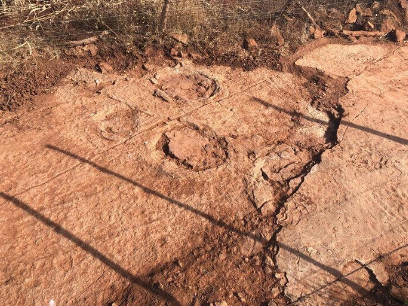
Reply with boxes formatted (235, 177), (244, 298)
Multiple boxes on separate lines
(277, 45), (408, 306)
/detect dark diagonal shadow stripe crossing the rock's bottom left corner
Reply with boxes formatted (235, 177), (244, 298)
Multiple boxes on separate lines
(0, 191), (182, 306)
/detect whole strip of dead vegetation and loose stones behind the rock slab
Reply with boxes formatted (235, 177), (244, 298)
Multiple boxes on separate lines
(0, 0), (406, 63)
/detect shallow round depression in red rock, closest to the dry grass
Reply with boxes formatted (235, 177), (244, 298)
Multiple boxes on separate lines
(161, 71), (219, 101)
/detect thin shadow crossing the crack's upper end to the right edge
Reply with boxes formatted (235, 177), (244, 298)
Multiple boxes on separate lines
(252, 97), (408, 145)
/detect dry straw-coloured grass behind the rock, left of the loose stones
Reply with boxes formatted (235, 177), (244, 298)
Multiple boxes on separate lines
(0, 0), (369, 67)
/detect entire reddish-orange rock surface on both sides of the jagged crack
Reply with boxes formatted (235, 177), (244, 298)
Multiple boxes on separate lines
(0, 44), (408, 305)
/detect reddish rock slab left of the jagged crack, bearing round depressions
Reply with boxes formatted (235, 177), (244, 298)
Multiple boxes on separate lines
(0, 62), (330, 305)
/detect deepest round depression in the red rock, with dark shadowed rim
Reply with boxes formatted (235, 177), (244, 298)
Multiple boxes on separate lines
(162, 127), (228, 171)
